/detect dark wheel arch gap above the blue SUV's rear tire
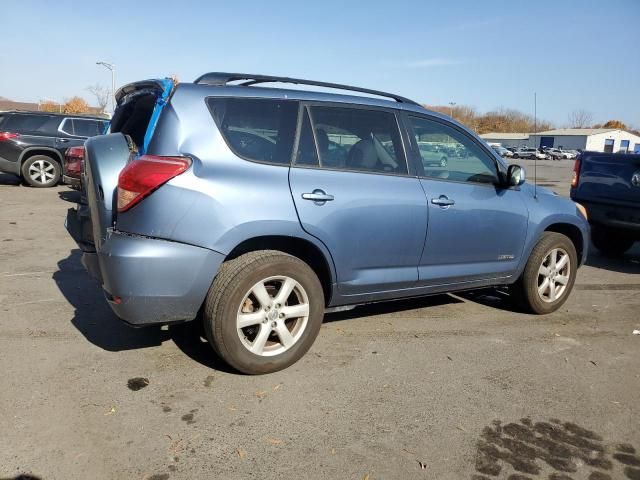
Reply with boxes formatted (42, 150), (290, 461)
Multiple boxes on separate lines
(225, 235), (335, 305)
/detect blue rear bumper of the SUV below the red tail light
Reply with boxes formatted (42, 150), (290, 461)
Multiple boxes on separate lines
(67, 208), (224, 326)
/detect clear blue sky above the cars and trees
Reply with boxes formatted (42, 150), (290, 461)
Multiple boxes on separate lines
(0, 0), (640, 128)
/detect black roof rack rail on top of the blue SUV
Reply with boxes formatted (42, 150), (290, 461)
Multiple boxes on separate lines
(193, 72), (420, 105)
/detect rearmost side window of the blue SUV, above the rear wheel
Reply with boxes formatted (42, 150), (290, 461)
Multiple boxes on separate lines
(207, 97), (298, 165)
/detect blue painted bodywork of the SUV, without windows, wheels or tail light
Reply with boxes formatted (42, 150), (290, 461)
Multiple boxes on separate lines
(67, 81), (588, 325)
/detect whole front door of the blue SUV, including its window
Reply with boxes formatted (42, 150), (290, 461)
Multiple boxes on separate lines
(408, 115), (528, 285)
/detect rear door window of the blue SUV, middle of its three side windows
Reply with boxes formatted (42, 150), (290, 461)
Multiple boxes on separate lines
(297, 106), (407, 174)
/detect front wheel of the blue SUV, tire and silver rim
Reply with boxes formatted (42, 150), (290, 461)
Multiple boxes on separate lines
(512, 232), (578, 315)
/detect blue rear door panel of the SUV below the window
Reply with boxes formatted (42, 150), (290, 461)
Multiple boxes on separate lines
(289, 168), (428, 296)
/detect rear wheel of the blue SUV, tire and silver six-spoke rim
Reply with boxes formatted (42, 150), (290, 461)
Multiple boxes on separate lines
(203, 250), (325, 375)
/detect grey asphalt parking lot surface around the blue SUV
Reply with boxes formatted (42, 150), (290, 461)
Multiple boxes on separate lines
(0, 160), (640, 480)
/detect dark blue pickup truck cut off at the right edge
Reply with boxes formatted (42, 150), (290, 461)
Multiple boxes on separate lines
(571, 152), (640, 255)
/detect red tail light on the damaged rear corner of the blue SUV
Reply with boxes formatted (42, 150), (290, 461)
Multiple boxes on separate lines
(118, 155), (191, 212)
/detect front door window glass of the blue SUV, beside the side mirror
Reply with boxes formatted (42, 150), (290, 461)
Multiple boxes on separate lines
(409, 116), (498, 183)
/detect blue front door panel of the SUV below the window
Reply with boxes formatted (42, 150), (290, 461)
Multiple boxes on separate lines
(418, 179), (529, 285)
